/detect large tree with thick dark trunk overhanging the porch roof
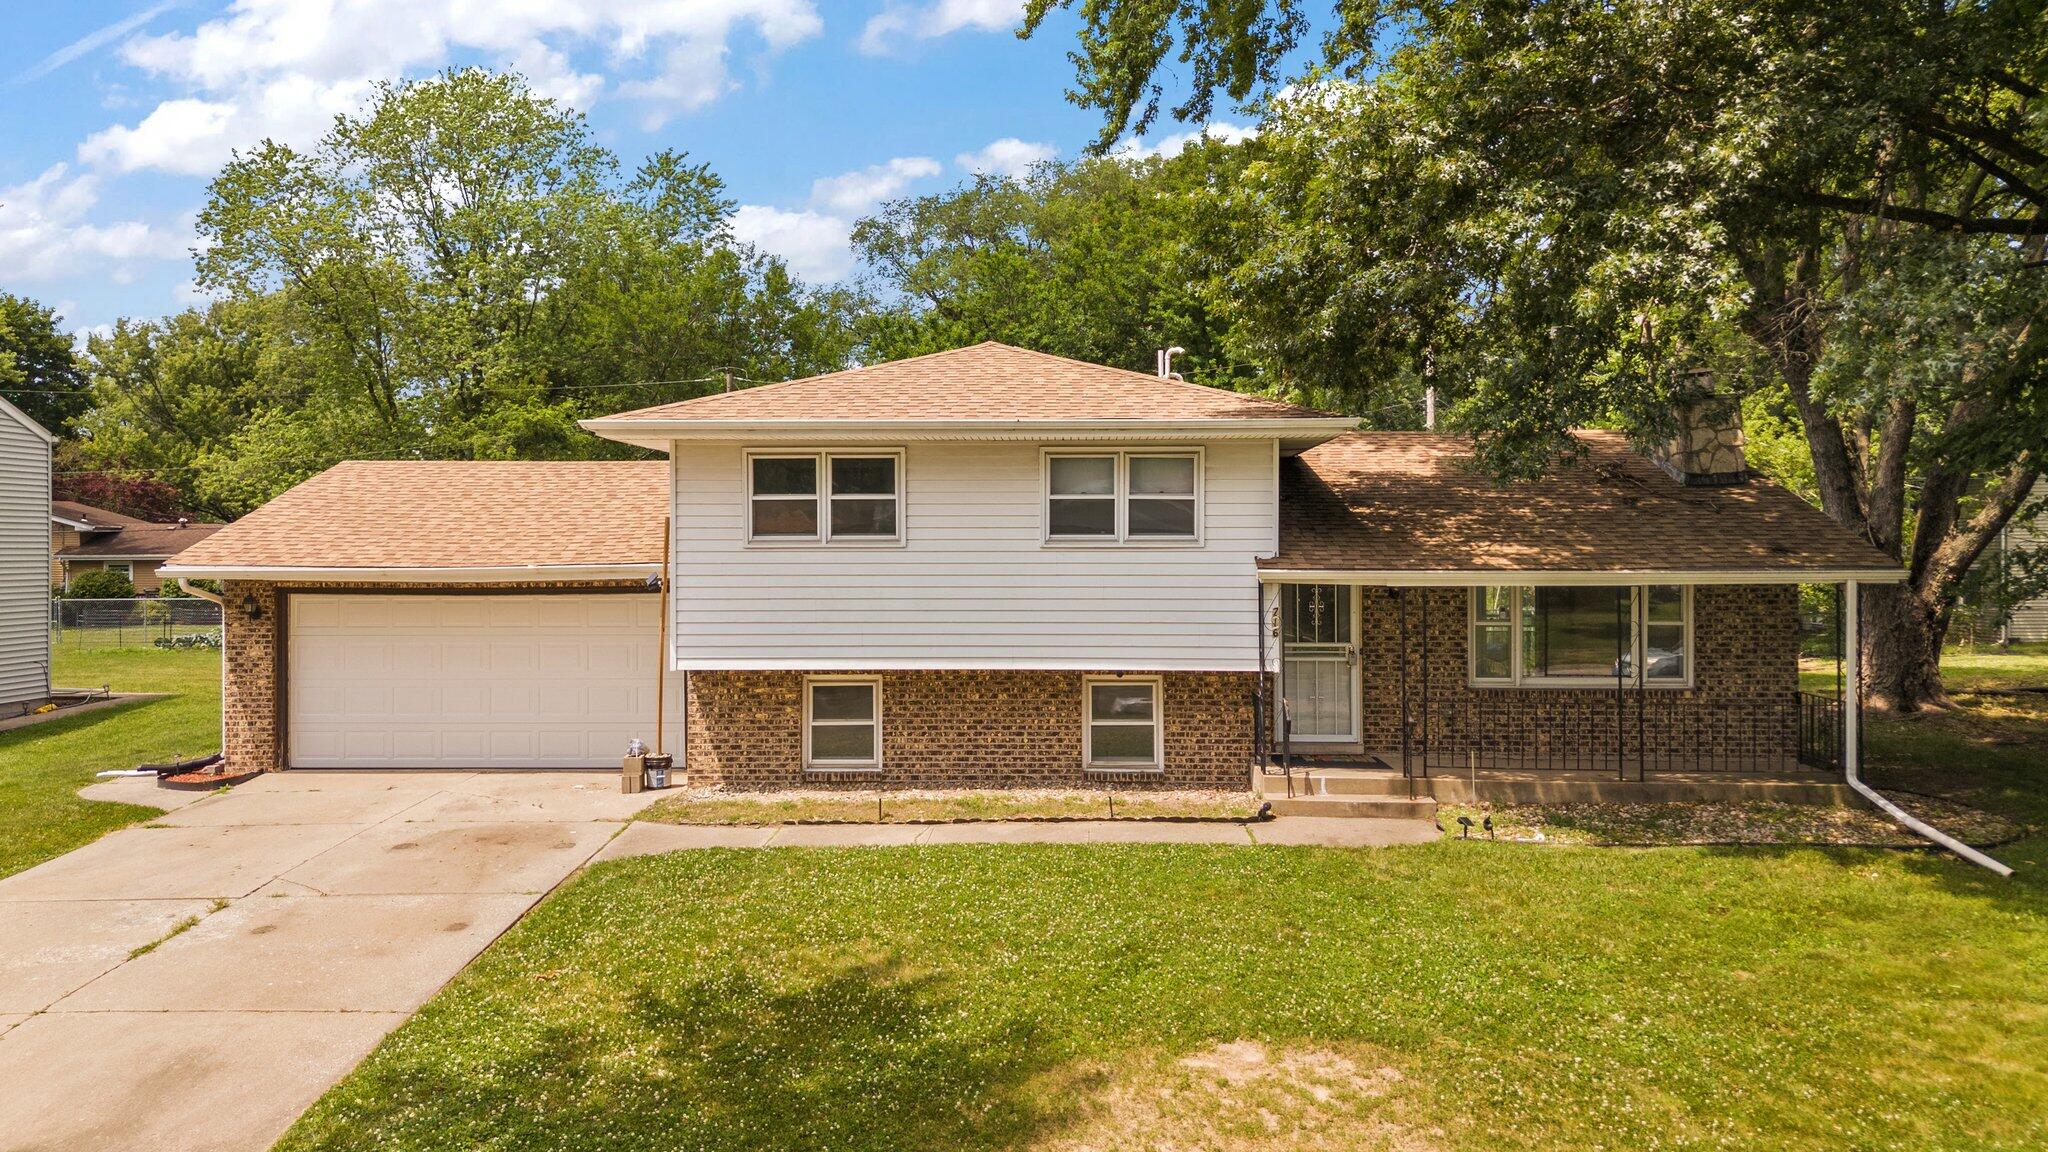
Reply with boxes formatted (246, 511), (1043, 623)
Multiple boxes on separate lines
(1026, 0), (2048, 709)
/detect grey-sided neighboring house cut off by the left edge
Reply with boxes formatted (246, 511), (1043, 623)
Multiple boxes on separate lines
(0, 400), (55, 715)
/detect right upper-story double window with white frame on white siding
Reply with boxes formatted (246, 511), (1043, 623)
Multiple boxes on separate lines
(1044, 449), (1202, 543)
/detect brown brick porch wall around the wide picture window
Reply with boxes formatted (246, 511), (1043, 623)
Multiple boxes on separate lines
(1360, 584), (1798, 769)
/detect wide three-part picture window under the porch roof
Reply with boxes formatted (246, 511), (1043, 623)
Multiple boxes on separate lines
(1468, 584), (1692, 689)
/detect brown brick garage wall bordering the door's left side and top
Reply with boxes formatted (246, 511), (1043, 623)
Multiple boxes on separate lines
(221, 580), (645, 773)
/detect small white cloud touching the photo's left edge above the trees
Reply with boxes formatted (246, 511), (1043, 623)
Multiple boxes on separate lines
(0, 164), (193, 283)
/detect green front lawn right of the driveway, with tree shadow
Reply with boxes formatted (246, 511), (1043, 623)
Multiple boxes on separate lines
(281, 639), (2048, 1152)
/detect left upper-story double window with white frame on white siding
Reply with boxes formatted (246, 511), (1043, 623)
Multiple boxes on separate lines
(745, 449), (903, 543)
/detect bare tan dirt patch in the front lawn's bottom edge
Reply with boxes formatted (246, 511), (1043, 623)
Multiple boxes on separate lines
(1032, 1039), (1444, 1152)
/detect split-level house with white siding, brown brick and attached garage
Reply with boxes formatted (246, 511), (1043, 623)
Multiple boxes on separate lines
(166, 344), (1898, 787)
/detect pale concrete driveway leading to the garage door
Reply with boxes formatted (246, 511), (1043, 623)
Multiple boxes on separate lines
(0, 771), (655, 1152)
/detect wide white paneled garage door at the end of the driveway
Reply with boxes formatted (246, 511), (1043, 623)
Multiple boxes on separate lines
(285, 592), (663, 769)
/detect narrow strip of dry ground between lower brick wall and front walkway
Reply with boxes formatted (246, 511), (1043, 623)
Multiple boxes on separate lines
(639, 789), (1260, 824)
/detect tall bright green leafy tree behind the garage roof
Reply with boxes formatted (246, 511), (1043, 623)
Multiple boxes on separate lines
(78, 70), (854, 506)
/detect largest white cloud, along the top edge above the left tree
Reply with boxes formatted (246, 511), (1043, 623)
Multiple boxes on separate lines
(80, 0), (823, 172)
